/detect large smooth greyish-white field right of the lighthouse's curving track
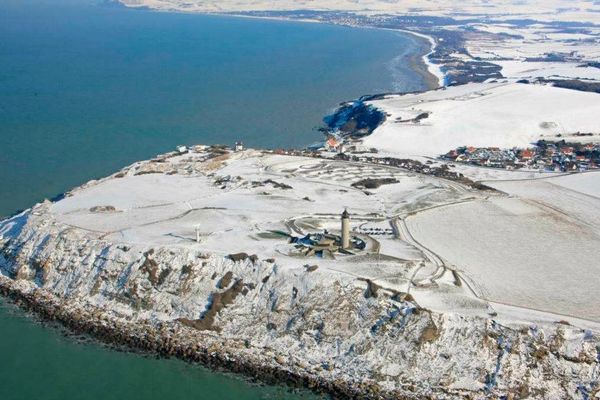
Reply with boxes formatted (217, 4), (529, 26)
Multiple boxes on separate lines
(407, 195), (600, 321)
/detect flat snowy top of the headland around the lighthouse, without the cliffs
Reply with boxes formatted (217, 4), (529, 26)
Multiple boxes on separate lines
(5, 148), (600, 322)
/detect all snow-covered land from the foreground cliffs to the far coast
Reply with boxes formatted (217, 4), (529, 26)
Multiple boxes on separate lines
(0, 0), (600, 399)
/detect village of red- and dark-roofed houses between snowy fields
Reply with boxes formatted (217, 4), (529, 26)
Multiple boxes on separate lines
(442, 140), (600, 172)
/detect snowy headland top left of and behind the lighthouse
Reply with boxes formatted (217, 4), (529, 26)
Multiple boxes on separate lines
(50, 152), (460, 267)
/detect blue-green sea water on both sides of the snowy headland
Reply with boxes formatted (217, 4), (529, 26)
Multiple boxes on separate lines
(0, 0), (432, 400)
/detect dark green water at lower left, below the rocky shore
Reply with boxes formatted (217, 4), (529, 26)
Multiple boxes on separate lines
(0, 298), (322, 400)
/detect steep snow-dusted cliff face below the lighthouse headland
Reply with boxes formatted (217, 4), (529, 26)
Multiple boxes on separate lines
(0, 152), (599, 399)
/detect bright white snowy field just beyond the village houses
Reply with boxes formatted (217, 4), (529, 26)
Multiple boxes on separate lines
(364, 82), (600, 156)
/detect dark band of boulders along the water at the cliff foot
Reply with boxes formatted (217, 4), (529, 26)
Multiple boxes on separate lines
(0, 274), (406, 400)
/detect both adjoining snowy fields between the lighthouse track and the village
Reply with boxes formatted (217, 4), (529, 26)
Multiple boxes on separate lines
(398, 166), (600, 321)
